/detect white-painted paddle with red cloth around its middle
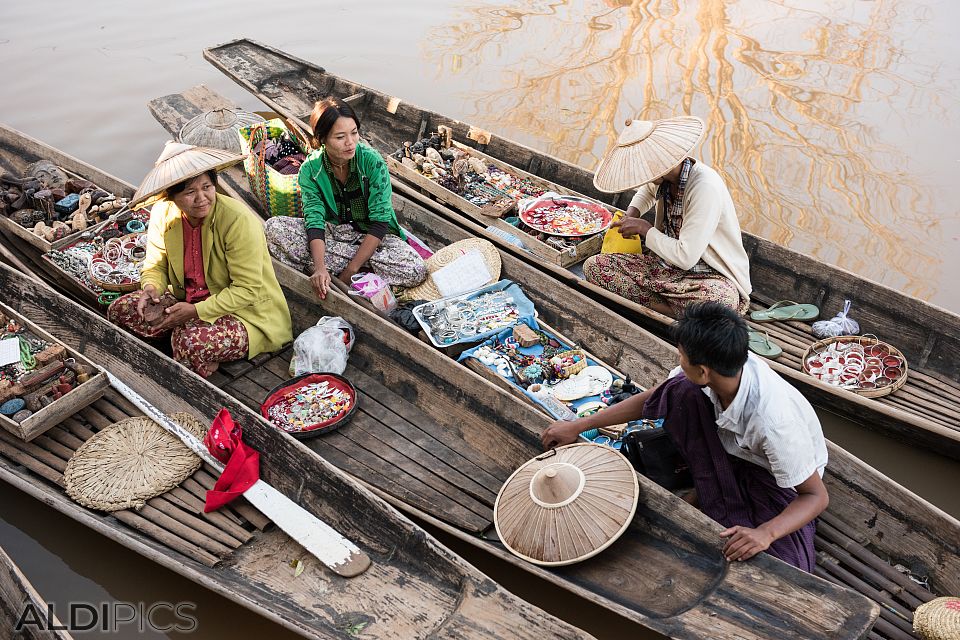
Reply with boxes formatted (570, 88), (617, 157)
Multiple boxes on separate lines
(106, 371), (370, 578)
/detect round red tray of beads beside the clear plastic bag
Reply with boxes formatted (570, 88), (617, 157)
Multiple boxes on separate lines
(260, 373), (357, 439)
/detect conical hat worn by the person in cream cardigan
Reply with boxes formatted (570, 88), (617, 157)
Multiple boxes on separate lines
(593, 116), (703, 193)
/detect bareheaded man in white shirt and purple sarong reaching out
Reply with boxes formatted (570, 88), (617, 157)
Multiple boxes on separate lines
(543, 302), (829, 572)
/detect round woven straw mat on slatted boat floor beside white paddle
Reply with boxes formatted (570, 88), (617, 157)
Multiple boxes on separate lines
(63, 413), (207, 511)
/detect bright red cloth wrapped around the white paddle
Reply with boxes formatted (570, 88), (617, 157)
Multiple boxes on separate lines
(203, 409), (260, 513)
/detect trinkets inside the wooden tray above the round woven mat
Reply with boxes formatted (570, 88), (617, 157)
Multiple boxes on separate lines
(0, 312), (94, 423)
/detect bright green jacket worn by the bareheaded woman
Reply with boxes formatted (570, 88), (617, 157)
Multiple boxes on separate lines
(298, 143), (407, 240)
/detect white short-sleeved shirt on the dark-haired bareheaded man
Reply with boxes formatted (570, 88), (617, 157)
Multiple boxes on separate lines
(670, 353), (827, 487)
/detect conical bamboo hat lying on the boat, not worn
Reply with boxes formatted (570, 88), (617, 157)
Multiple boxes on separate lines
(493, 443), (640, 566)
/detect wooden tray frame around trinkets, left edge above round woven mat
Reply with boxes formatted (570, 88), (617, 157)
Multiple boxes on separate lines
(0, 302), (110, 441)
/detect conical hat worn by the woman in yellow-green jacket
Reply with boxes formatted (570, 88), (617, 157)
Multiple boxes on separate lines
(130, 140), (247, 208)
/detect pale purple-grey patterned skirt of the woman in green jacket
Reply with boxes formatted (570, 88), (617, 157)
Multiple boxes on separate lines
(263, 216), (427, 287)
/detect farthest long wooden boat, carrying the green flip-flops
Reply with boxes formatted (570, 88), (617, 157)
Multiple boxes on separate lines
(204, 39), (960, 459)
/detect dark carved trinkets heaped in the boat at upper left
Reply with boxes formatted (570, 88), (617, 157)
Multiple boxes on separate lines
(0, 165), (127, 242)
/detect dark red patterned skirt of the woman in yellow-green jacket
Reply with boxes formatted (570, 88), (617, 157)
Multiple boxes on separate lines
(107, 291), (250, 378)
